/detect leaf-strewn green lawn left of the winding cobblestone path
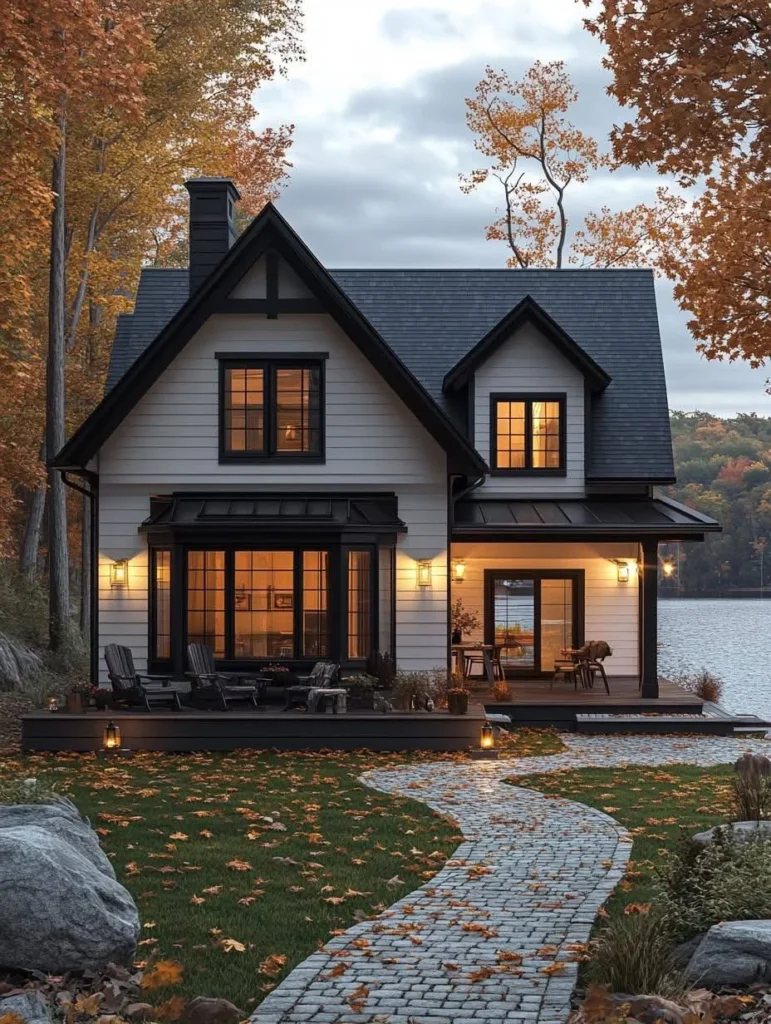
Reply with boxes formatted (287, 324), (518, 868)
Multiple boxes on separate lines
(0, 752), (462, 1011)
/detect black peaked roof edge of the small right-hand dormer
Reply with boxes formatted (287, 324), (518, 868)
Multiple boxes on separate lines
(443, 295), (610, 391)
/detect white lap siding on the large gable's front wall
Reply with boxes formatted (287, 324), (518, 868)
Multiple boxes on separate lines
(98, 315), (447, 679)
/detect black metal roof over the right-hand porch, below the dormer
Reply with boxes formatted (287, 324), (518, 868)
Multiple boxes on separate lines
(453, 497), (721, 541)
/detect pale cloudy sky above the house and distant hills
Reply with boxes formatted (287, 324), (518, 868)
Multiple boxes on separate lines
(257, 0), (771, 416)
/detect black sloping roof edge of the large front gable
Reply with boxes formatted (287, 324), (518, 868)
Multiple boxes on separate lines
(51, 203), (486, 473)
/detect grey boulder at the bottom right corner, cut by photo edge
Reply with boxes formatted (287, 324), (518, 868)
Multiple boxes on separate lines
(685, 921), (771, 988)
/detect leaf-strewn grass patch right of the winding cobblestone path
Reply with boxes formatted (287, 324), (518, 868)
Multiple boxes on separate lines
(510, 765), (733, 916)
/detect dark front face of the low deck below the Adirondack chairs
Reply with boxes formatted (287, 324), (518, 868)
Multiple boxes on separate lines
(22, 703), (484, 752)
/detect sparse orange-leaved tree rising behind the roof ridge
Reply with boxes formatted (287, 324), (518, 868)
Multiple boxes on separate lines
(462, 60), (684, 269)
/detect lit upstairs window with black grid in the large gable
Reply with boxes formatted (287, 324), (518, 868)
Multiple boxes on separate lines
(220, 358), (324, 462)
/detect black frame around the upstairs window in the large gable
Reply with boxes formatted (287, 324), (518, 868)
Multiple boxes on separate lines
(216, 353), (327, 465)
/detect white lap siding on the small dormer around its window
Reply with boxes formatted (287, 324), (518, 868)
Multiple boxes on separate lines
(473, 325), (585, 497)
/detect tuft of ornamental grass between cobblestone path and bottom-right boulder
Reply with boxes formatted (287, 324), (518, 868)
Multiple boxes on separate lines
(587, 913), (682, 995)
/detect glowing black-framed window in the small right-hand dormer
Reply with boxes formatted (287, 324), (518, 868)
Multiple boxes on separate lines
(490, 393), (565, 476)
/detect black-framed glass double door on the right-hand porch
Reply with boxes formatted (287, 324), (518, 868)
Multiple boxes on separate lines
(484, 569), (584, 676)
